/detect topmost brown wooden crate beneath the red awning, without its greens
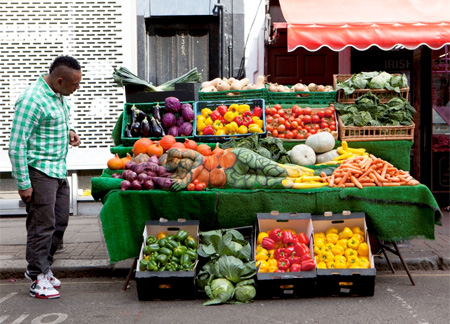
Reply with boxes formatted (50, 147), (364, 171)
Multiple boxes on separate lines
(333, 74), (409, 104)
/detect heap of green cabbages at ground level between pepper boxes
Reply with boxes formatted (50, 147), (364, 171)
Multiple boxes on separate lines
(196, 229), (256, 306)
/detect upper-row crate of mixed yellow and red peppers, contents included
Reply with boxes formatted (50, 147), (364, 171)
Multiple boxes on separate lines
(194, 99), (266, 142)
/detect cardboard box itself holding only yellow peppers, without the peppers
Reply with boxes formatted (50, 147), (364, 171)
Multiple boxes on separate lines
(312, 212), (376, 296)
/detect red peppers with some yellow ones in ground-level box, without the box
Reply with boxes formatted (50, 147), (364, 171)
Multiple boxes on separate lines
(255, 228), (316, 272)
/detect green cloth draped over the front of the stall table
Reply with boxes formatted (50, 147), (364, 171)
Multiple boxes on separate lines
(92, 175), (441, 263)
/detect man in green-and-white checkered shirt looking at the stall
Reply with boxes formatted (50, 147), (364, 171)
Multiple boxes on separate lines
(9, 56), (81, 299)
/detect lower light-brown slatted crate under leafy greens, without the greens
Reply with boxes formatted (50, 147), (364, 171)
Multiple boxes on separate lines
(338, 115), (415, 142)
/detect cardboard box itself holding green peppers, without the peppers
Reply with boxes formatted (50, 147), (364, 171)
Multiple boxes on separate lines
(135, 220), (199, 300)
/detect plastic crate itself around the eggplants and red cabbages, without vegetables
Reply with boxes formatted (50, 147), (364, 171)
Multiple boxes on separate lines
(121, 101), (196, 146)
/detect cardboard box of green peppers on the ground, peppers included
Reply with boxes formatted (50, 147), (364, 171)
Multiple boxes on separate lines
(135, 220), (199, 300)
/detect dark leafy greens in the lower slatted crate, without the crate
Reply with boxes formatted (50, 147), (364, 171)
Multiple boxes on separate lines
(335, 91), (416, 127)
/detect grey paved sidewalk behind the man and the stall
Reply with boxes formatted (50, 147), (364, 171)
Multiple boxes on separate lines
(0, 211), (450, 279)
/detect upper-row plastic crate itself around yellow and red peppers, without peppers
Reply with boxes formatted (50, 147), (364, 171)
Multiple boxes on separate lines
(194, 99), (266, 142)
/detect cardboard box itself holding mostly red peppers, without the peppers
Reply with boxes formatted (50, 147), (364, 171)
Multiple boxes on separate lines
(254, 212), (316, 299)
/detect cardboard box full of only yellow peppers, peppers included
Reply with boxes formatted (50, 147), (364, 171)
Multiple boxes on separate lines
(312, 212), (376, 296)
